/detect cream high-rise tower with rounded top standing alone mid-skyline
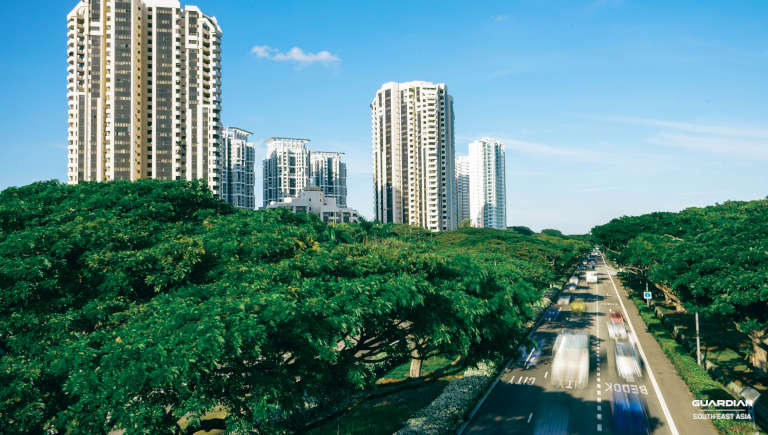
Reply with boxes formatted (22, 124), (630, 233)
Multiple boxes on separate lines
(371, 81), (458, 231)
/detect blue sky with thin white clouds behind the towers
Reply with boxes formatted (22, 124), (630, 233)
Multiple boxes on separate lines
(0, 0), (768, 233)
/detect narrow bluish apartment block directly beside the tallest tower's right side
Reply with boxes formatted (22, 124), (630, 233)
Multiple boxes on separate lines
(221, 127), (256, 210)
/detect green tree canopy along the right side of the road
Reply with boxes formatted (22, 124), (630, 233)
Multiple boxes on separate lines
(592, 200), (768, 331)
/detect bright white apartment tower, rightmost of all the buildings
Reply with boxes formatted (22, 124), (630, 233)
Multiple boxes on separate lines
(469, 138), (507, 230)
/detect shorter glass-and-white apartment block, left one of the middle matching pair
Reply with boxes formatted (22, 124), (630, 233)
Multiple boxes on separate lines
(263, 137), (311, 207)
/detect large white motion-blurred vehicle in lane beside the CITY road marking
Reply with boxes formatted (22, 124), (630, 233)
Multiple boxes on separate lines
(550, 332), (589, 389)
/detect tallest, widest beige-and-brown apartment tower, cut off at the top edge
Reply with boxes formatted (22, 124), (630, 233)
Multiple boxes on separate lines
(67, 0), (222, 194)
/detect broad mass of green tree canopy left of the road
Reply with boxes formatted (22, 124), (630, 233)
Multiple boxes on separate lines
(0, 180), (587, 433)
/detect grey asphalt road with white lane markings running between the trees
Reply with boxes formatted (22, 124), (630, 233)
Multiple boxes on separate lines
(463, 254), (717, 435)
